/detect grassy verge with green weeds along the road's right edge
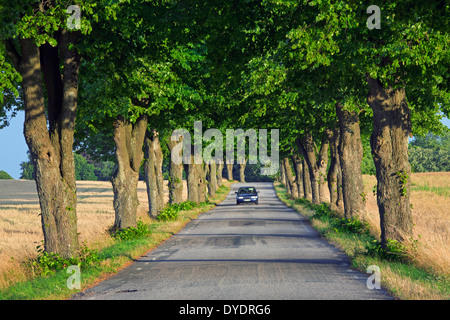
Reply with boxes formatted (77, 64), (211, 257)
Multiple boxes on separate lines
(274, 182), (450, 300)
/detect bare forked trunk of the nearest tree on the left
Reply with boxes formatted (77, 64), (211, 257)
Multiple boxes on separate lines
(18, 35), (80, 257)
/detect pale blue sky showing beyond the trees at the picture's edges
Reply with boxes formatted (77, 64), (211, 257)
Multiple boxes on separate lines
(0, 111), (450, 179)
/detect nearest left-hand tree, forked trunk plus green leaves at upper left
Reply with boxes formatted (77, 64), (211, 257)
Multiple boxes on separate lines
(0, 0), (94, 257)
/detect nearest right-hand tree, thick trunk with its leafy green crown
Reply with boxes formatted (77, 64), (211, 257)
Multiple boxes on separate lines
(264, 1), (449, 246)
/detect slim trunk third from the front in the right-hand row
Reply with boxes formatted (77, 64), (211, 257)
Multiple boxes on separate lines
(327, 126), (344, 214)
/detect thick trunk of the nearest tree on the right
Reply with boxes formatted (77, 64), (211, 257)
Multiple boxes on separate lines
(367, 78), (413, 246)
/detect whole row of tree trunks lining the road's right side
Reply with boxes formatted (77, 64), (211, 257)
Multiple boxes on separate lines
(281, 87), (413, 247)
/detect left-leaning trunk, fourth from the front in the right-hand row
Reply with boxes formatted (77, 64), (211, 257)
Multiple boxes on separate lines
(295, 132), (320, 204)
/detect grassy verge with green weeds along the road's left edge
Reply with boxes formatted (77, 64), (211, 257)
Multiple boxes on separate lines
(0, 180), (234, 300)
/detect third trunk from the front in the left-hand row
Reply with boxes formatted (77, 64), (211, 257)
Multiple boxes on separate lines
(144, 130), (164, 218)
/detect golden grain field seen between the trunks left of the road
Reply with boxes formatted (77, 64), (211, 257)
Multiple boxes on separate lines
(0, 180), (187, 288)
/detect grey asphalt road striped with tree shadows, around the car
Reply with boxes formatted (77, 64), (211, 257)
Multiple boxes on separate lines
(73, 183), (392, 300)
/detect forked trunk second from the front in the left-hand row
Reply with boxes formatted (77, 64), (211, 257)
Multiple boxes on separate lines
(112, 116), (147, 231)
